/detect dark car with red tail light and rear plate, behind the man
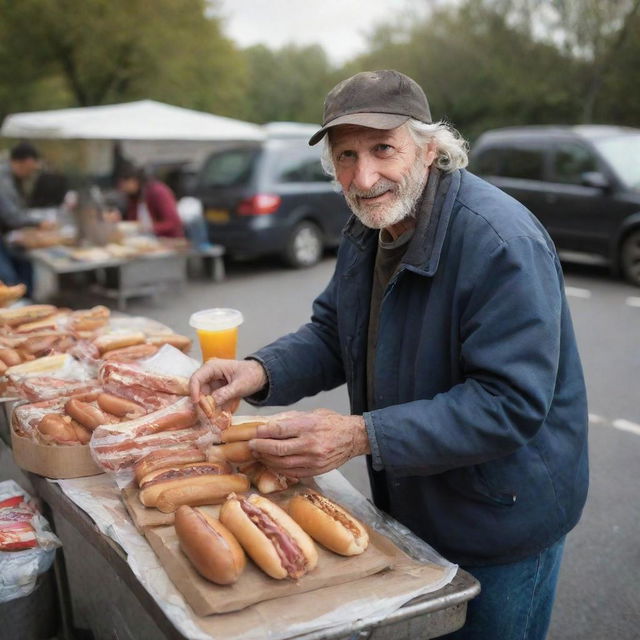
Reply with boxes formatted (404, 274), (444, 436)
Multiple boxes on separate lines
(193, 136), (350, 267)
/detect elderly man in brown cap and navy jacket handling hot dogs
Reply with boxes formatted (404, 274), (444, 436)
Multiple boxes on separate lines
(191, 71), (588, 640)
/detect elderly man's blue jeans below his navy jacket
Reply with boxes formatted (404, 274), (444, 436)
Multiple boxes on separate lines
(444, 537), (565, 640)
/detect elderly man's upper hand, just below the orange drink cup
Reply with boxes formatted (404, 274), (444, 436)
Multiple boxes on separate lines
(189, 358), (267, 410)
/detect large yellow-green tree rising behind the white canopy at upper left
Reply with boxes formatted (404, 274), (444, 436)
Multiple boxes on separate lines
(0, 0), (244, 113)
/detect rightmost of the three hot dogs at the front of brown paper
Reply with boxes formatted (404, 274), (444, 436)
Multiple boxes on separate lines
(288, 489), (369, 556)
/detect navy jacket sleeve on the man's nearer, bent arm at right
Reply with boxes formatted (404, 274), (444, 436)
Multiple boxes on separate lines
(364, 236), (564, 475)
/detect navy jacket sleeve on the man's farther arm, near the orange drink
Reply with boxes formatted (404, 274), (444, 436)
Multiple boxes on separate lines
(246, 273), (345, 406)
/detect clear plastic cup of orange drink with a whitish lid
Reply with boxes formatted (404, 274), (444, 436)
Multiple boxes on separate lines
(189, 308), (244, 362)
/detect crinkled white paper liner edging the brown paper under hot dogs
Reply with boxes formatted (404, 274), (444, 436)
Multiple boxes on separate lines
(52, 470), (457, 640)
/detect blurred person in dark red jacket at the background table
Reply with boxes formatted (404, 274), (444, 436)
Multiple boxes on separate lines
(117, 165), (184, 238)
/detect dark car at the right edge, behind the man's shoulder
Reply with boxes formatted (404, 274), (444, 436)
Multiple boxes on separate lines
(470, 125), (640, 286)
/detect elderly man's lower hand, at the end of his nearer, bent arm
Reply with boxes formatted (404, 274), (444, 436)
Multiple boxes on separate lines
(250, 409), (370, 478)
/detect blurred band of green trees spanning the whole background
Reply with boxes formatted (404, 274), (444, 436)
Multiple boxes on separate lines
(0, 0), (640, 134)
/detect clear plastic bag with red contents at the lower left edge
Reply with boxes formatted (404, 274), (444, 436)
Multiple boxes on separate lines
(0, 480), (61, 602)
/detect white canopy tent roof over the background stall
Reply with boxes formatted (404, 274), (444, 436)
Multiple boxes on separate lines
(0, 100), (266, 173)
